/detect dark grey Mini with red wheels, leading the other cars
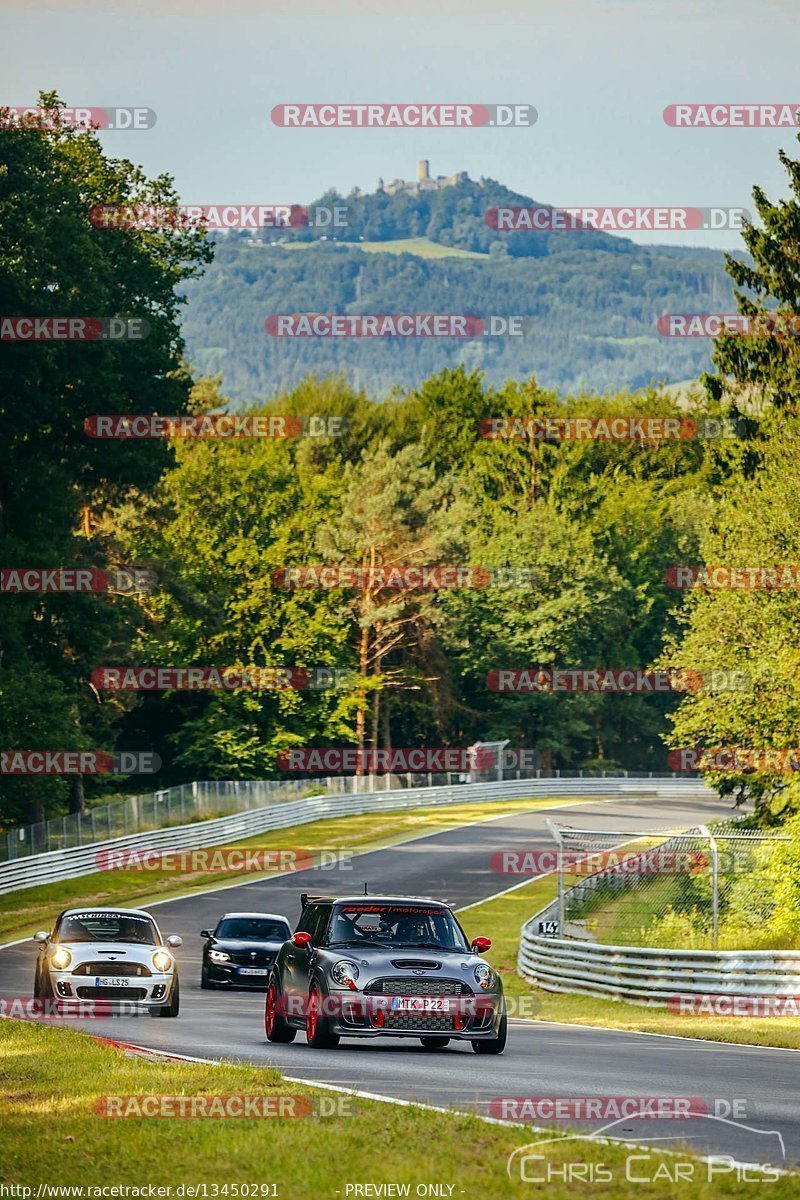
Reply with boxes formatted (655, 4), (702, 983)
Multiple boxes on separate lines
(264, 894), (507, 1054)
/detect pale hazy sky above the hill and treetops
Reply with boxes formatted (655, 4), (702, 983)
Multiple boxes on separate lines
(0, 0), (800, 247)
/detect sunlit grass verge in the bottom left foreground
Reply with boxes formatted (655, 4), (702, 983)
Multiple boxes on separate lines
(0, 1020), (796, 1200)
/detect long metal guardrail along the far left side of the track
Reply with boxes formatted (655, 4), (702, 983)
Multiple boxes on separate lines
(0, 775), (715, 894)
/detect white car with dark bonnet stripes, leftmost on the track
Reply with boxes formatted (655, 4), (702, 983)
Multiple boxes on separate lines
(34, 907), (182, 1016)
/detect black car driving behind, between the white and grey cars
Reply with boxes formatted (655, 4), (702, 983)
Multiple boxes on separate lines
(200, 912), (291, 988)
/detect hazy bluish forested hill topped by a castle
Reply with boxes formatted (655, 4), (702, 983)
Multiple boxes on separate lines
(184, 171), (733, 403)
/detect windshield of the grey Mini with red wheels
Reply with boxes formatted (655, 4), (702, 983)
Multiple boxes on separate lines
(329, 904), (469, 950)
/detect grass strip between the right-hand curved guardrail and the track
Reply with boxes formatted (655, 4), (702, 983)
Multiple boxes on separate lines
(459, 876), (800, 1050)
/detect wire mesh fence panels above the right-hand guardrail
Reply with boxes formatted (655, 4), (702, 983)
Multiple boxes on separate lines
(547, 821), (789, 949)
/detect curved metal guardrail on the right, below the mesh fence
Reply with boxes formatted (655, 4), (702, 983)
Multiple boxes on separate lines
(517, 825), (800, 1006)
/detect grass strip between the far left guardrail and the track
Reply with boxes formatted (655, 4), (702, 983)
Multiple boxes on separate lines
(0, 797), (556, 941)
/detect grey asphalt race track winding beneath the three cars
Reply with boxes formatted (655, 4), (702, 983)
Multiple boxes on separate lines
(0, 796), (800, 1165)
